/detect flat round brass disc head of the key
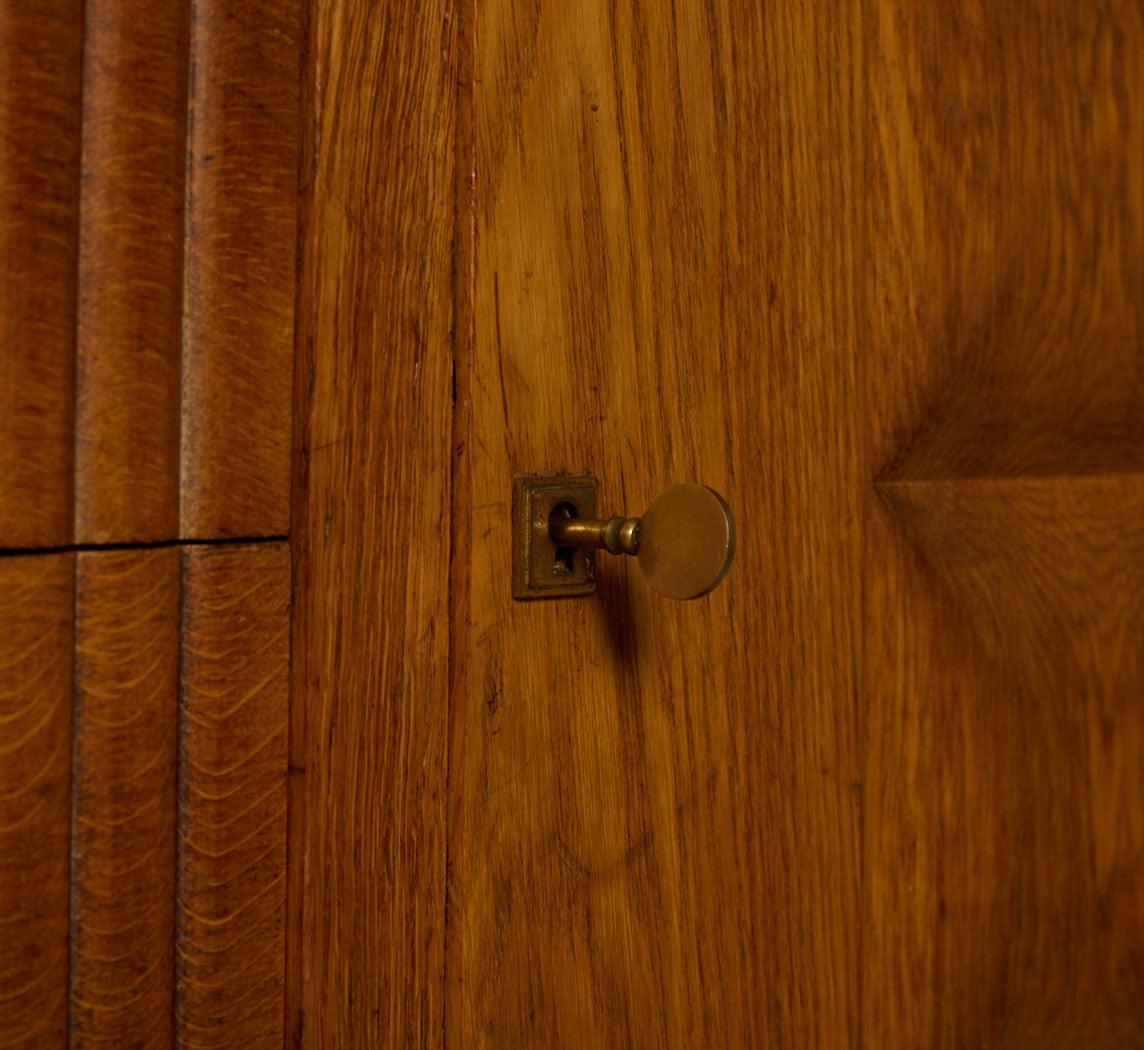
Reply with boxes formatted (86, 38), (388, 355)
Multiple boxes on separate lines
(638, 485), (734, 599)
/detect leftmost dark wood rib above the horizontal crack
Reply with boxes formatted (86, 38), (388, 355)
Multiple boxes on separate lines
(0, 0), (84, 548)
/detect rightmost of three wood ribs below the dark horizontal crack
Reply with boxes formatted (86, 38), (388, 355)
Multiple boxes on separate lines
(175, 543), (291, 1050)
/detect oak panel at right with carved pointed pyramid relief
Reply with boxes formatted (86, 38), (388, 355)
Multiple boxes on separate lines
(861, 0), (1144, 1048)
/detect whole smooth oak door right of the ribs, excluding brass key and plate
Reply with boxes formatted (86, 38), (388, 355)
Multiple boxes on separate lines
(292, 0), (1144, 1048)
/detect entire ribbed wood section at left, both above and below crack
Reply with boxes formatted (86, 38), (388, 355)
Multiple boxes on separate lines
(0, 0), (302, 1050)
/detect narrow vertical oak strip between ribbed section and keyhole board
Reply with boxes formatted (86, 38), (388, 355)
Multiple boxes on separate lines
(291, 0), (458, 1048)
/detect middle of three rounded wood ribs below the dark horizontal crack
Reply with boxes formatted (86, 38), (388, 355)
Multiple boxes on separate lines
(71, 547), (180, 1048)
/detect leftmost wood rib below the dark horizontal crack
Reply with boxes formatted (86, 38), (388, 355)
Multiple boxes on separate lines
(0, 554), (76, 1050)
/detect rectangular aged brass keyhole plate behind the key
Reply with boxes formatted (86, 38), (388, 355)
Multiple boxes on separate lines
(513, 475), (597, 602)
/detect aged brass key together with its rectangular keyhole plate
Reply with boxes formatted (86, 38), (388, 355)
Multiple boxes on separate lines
(513, 476), (734, 599)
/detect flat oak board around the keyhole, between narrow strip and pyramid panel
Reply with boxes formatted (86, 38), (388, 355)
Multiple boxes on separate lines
(446, 0), (863, 1048)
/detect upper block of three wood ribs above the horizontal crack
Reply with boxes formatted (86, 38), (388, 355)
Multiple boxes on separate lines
(0, 0), (302, 549)
